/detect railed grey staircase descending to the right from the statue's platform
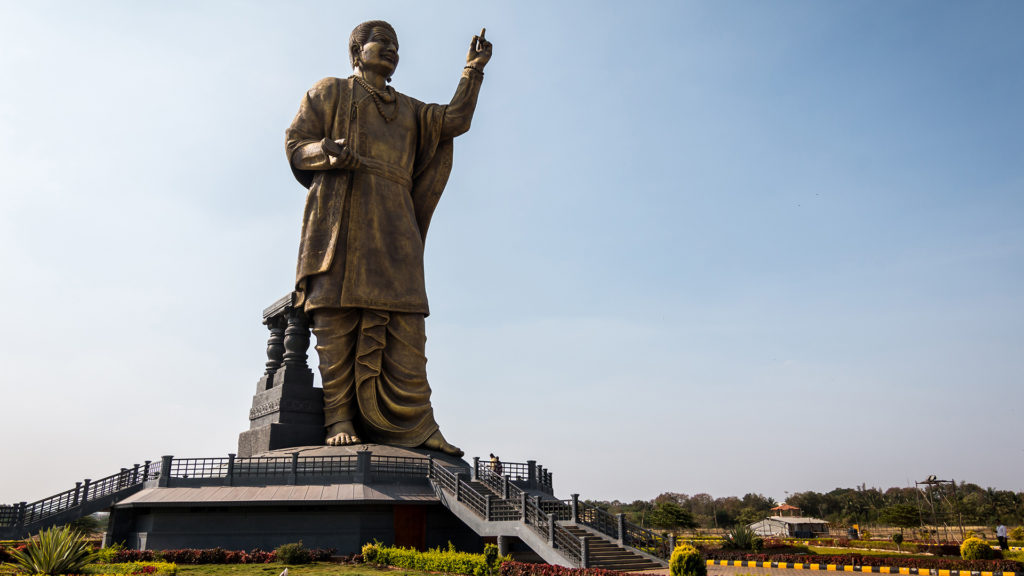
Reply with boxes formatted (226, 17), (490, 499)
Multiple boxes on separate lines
(430, 459), (674, 571)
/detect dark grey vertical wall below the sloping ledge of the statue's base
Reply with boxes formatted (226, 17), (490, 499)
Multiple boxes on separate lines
(106, 503), (483, 554)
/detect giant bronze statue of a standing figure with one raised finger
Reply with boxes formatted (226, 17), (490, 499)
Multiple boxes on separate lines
(286, 20), (492, 456)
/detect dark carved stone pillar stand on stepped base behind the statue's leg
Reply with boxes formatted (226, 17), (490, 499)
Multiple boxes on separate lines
(239, 292), (325, 458)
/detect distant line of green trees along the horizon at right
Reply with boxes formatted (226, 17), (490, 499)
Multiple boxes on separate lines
(589, 482), (1024, 529)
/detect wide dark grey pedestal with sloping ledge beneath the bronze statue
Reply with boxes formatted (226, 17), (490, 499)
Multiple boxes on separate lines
(106, 445), (483, 554)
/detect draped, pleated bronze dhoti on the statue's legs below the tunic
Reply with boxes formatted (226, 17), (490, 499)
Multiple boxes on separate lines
(312, 308), (437, 447)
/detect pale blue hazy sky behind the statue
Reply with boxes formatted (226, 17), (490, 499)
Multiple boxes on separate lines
(0, 1), (1024, 502)
